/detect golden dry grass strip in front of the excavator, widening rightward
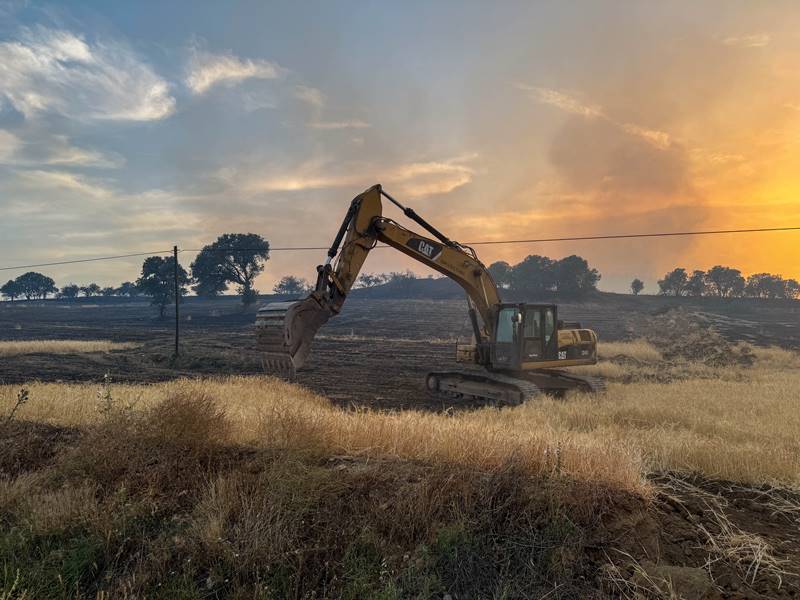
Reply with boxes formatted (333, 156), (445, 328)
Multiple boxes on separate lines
(0, 341), (800, 494)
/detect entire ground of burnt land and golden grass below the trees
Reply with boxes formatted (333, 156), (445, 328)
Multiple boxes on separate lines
(0, 297), (800, 598)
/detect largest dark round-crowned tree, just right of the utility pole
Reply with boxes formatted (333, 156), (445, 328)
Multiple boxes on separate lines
(192, 233), (269, 306)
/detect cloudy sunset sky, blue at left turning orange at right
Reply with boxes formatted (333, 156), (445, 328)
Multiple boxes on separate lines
(0, 0), (800, 292)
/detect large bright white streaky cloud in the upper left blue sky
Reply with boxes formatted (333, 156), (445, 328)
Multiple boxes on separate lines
(0, 27), (175, 121)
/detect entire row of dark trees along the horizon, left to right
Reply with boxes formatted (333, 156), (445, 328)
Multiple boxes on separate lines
(0, 239), (800, 316)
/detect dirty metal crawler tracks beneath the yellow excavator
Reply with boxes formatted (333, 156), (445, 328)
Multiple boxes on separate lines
(425, 370), (606, 406)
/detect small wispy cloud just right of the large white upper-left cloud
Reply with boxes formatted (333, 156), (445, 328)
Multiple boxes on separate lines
(186, 50), (285, 94)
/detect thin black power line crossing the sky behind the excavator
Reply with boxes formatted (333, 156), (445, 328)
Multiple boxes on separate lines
(0, 227), (800, 271)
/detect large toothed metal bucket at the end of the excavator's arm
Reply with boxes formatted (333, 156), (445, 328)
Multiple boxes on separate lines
(256, 295), (334, 380)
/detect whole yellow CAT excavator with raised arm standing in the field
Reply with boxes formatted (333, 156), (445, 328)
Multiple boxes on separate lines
(256, 185), (605, 405)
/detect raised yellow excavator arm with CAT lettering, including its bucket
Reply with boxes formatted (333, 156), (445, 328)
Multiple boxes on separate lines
(256, 185), (500, 377)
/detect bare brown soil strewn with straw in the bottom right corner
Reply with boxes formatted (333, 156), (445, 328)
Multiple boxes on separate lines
(596, 474), (800, 600)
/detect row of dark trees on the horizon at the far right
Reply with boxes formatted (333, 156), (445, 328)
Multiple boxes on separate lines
(658, 265), (800, 299)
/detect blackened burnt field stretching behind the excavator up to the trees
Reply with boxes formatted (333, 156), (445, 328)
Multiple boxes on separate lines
(0, 294), (800, 408)
